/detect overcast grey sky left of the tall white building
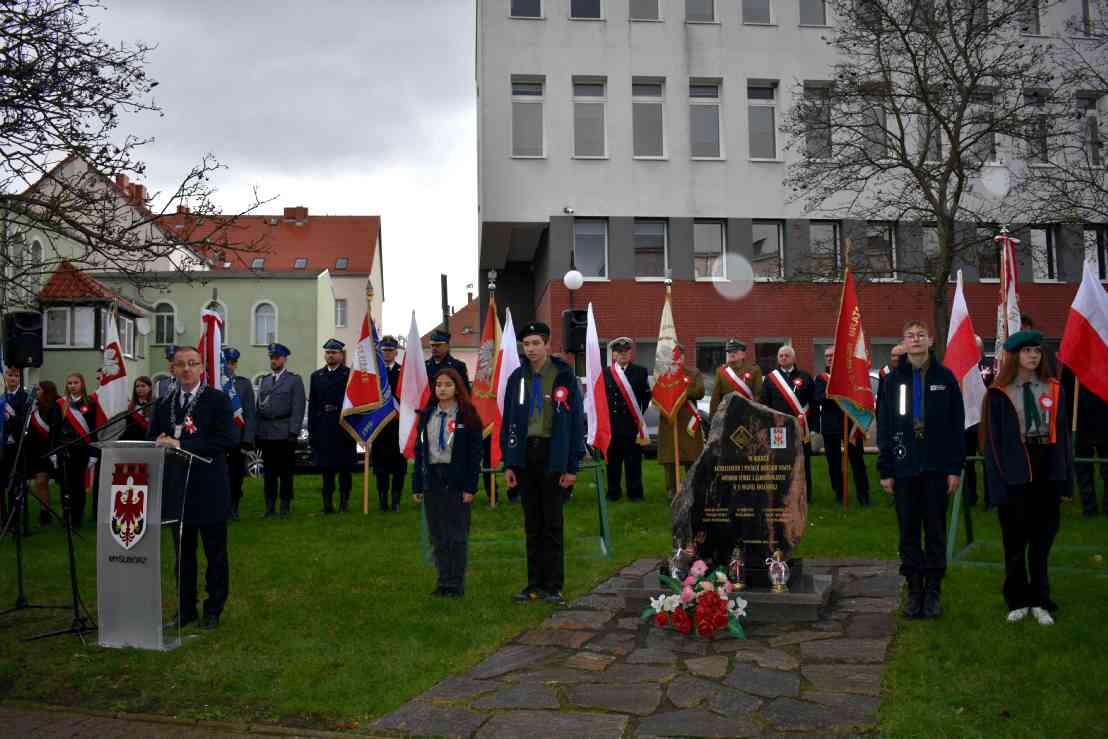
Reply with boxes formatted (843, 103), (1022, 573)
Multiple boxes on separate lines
(92, 0), (476, 333)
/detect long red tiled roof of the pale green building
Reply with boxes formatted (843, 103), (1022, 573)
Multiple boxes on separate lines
(161, 206), (381, 273)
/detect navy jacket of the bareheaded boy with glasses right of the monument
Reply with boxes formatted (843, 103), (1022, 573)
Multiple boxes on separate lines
(878, 351), (966, 480)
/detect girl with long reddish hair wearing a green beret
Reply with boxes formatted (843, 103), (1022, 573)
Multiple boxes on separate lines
(981, 331), (1074, 626)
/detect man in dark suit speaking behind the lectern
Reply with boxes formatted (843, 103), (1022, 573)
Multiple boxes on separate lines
(147, 347), (237, 629)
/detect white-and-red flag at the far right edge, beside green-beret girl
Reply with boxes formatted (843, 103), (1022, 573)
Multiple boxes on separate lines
(1058, 255), (1108, 401)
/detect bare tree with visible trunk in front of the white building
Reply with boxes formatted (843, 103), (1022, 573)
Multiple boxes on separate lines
(783, 0), (1059, 347)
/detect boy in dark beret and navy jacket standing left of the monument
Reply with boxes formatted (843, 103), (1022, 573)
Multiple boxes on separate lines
(500, 322), (585, 605)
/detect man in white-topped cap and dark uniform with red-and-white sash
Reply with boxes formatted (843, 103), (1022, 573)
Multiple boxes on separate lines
(604, 336), (650, 501)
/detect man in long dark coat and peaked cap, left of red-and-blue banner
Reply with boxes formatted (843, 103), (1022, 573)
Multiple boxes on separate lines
(308, 339), (357, 513)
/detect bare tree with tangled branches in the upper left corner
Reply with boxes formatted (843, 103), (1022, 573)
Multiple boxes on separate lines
(0, 0), (268, 309)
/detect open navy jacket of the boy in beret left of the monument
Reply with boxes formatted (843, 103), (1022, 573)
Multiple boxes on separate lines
(500, 357), (585, 474)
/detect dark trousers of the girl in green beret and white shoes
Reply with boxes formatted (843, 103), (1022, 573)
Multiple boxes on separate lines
(996, 445), (1060, 610)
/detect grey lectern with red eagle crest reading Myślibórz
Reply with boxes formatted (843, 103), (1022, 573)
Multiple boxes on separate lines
(96, 441), (211, 650)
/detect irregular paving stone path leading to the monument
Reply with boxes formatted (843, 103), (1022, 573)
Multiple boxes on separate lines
(371, 558), (901, 739)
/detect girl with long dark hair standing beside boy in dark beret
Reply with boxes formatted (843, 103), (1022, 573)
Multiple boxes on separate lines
(412, 368), (482, 598)
